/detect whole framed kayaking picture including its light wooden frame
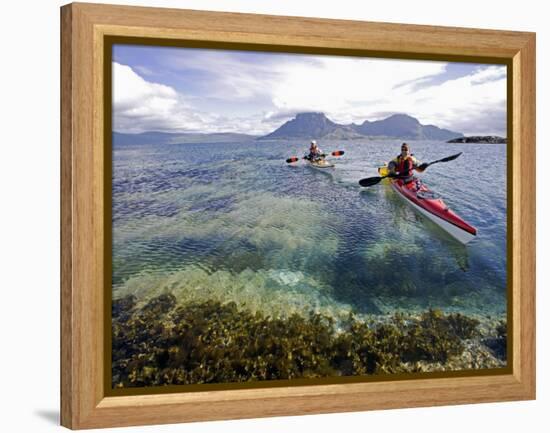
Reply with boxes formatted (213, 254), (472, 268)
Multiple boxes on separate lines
(61, 4), (535, 429)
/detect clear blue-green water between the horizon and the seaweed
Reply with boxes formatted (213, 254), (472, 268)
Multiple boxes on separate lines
(113, 141), (506, 317)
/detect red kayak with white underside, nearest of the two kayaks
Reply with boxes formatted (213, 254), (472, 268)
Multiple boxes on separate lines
(391, 179), (477, 244)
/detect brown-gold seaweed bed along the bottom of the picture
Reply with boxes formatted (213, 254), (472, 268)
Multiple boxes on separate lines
(112, 294), (488, 387)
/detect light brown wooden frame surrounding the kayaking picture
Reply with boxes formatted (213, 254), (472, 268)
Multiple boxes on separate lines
(61, 3), (535, 429)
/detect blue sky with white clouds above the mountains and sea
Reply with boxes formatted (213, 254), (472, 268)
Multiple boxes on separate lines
(113, 45), (506, 136)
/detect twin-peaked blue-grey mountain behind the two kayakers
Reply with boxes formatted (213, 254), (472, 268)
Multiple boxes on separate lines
(259, 113), (463, 140)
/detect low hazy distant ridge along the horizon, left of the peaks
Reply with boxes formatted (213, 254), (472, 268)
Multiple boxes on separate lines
(113, 131), (257, 146)
